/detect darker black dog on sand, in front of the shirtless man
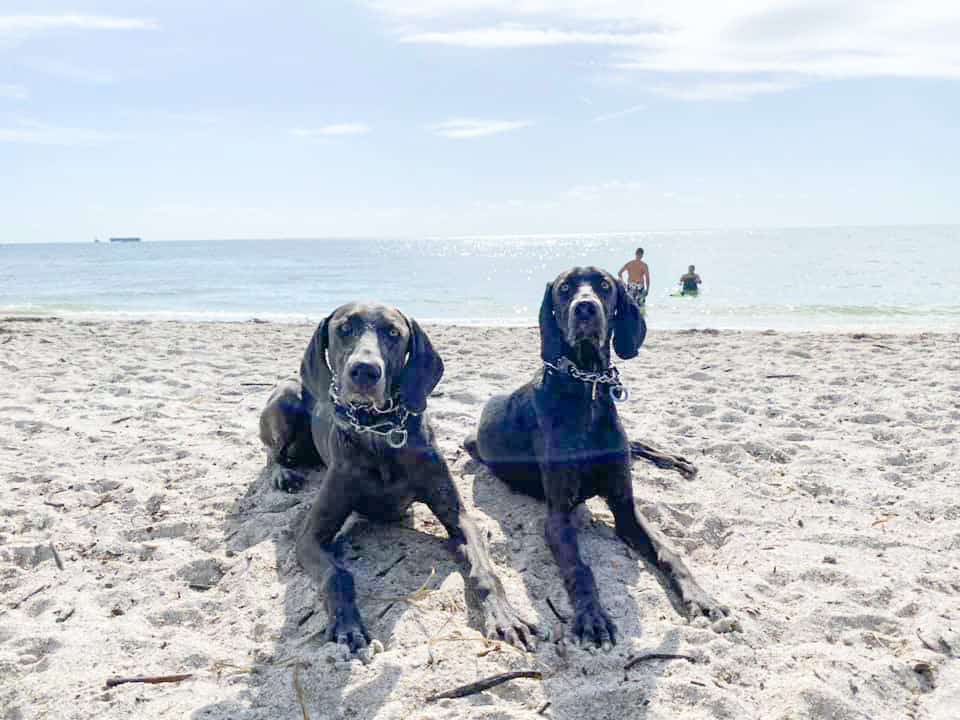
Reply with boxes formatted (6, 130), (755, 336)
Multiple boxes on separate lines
(464, 267), (726, 645)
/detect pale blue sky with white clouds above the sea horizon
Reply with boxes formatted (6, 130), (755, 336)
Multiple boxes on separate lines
(0, 0), (960, 242)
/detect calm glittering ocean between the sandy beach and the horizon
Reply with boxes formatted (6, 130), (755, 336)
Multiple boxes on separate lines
(0, 226), (960, 332)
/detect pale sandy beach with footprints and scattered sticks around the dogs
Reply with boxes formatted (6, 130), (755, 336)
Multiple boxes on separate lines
(0, 320), (960, 720)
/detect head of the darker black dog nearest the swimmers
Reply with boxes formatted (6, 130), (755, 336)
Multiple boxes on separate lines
(540, 267), (646, 369)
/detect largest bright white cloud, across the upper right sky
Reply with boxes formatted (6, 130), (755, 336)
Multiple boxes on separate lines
(371, 0), (960, 86)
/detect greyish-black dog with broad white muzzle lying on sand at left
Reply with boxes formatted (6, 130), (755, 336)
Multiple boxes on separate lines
(260, 303), (537, 651)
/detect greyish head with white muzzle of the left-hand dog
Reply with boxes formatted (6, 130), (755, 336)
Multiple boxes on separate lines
(300, 303), (443, 412)
